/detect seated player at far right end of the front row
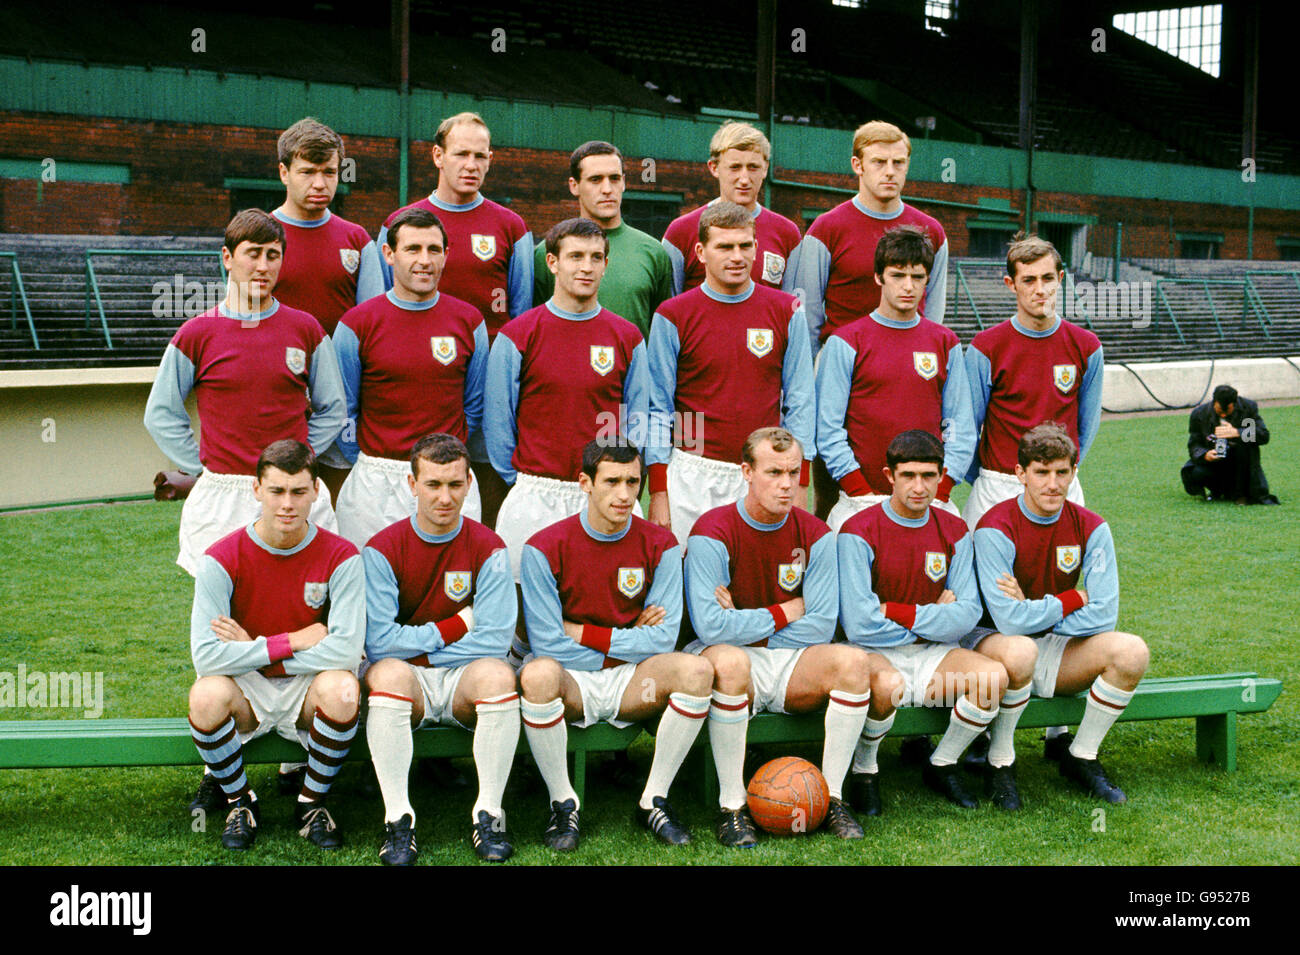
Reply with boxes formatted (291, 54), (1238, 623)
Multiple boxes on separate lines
(969, 422), (1151, 803)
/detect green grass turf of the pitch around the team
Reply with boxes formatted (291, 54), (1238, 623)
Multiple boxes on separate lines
(0, 405), (1300, 865)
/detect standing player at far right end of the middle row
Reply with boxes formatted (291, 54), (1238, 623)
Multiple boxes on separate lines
(962, 233), (1105, 530)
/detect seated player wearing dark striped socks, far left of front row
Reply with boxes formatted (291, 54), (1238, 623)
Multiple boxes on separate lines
(190, 440), (365, 848)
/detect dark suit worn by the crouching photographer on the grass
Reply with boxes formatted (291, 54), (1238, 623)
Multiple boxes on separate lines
(1182, 395), (1277, 504)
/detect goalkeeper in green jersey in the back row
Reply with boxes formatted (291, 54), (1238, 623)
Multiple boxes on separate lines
(533, 140), (672, 338)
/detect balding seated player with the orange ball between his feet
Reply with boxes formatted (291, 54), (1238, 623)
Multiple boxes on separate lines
(685, 427), (871, 848)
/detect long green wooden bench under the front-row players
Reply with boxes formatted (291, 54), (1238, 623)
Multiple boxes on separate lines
(0, 673), (1282, 796)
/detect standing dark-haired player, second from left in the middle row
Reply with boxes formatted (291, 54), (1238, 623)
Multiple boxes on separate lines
(334, 209), (488, 547)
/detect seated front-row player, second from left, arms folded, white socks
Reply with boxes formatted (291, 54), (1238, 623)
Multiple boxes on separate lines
(361, 434), (519, 865)
